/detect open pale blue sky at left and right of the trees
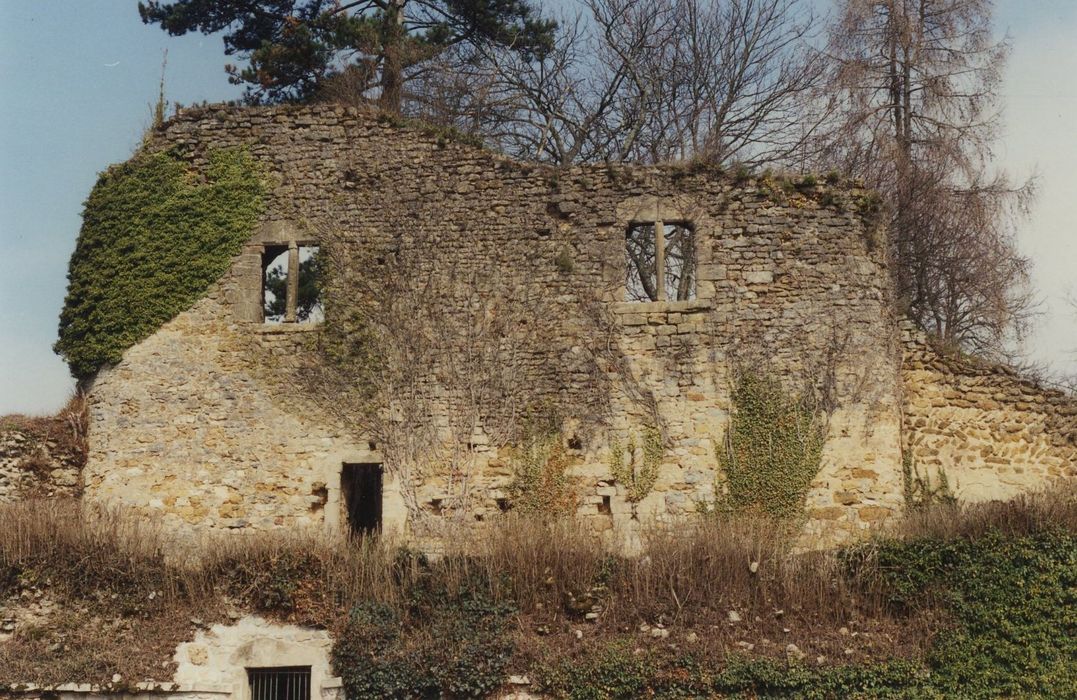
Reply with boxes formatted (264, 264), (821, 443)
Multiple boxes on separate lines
(0, 0), (1077, 415)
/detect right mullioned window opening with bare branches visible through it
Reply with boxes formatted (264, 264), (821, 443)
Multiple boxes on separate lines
(625, 220), (696, 302)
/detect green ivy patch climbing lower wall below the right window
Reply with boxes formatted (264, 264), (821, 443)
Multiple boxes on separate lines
(718, 372), (826, 518)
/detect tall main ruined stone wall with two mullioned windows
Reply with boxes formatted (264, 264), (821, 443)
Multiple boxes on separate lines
(85, 102), (901, 542)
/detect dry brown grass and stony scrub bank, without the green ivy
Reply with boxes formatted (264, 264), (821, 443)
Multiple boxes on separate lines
(0, 488), (1077, 683)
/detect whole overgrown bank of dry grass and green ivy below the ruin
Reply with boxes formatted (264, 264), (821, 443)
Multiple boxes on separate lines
(0, 489), (1077, 698)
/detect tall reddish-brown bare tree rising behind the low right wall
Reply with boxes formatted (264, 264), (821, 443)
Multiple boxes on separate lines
(819, 0), (1035, 354)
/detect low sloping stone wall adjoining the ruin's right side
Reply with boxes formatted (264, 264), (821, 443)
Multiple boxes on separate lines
(901, 323), (1077, 501)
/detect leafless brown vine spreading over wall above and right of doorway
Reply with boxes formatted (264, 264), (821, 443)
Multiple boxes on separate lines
(292, 226), (547, 518)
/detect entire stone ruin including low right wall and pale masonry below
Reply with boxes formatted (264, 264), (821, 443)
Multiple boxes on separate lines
(0, 107), (1077, 698)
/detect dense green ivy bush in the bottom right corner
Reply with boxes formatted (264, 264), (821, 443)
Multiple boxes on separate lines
(878, 531), (1077, 698)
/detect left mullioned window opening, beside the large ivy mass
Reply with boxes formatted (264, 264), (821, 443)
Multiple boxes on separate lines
(262, 241), (324, 323)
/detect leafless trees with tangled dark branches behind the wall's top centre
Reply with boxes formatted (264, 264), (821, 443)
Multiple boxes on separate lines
(454, 0), (823, 165)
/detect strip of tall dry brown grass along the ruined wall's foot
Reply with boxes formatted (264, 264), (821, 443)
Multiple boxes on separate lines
(0, 487), (1077, 646)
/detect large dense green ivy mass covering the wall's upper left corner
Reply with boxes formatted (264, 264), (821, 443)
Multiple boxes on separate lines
(54, 144), (265, 379)
